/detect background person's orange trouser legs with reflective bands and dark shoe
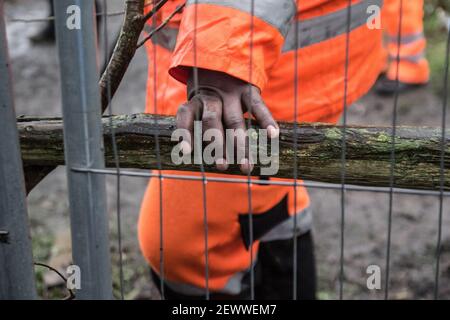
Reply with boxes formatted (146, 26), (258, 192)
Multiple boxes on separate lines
(375, 0), (430, 95)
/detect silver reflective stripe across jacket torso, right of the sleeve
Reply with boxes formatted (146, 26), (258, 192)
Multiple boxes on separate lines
(283, 0), (383, 52)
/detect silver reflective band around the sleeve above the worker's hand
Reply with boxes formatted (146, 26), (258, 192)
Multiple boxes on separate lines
(187, 0), (297, 36)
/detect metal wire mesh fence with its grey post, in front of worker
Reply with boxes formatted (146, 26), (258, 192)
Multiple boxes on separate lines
(0, 0), (450, 300)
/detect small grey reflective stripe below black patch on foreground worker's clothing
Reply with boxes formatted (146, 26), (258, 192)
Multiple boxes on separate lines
(260, 208), (312, 242)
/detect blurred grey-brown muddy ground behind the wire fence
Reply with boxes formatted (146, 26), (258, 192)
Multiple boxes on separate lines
(6, 0), (450, 299)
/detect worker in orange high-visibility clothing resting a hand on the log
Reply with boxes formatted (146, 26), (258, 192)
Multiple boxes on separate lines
(138, 0), (383, 299)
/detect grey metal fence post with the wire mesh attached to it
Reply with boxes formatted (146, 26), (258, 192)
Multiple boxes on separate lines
(53, 0), (112, 299)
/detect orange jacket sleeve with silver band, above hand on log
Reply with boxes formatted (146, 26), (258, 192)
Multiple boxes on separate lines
(169, 0), (297, 90)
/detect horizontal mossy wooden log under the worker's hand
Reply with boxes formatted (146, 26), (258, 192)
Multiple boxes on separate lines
(18, 114), (450, 190)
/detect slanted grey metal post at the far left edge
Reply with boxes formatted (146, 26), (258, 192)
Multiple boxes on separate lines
(0, 1), (36, 299)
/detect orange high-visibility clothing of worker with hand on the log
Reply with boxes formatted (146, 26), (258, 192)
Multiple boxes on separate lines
(139, 0), (383, 294)
